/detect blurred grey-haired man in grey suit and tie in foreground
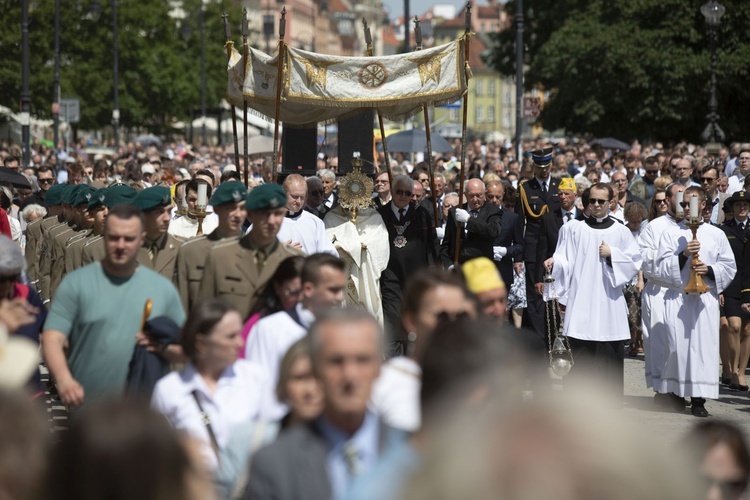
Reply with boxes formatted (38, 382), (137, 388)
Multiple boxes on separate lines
(245, 309), (405, 500)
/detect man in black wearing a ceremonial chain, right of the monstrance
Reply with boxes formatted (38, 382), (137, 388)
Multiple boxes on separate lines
(378, 175), (438, 355)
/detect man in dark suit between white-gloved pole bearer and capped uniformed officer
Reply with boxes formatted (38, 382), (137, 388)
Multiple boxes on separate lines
(486, 181), (523, 289)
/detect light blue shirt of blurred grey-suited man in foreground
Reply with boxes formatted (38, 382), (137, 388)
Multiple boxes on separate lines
(318, 412), (380, 500)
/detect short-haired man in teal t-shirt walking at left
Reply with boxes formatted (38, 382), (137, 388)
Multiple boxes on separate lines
(42, 204), (185, 409)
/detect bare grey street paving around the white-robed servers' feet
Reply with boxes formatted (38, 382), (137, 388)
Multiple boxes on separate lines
(624, 355), (750, 445)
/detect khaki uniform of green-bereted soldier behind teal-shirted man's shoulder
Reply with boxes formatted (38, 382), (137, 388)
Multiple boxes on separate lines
(175, 231), (239, 312)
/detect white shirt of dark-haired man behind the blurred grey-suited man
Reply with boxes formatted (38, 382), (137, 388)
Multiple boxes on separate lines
(245, 303), (315, 420)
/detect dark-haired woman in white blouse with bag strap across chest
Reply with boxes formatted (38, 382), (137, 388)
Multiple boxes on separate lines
(151, 299), (270, 491)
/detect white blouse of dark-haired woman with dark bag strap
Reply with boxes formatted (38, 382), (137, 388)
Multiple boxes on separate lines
(151, 360), (272, 470)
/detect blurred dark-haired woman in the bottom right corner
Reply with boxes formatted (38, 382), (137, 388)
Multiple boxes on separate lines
(683, 420), (750, 500)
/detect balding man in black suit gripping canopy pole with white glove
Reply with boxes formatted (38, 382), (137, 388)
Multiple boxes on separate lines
(440, 179), (500, 268)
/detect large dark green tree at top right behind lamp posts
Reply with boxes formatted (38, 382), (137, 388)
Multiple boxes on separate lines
(488, 0), (750, 141)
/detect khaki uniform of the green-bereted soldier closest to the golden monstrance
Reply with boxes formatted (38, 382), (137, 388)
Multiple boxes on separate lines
(198, 235), (303, 319)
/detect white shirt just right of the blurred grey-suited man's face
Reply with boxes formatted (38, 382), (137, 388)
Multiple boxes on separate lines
(369, 356), (422, 432)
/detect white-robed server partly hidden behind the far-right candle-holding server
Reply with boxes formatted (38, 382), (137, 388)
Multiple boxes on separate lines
(638, 182), (685, 407)
